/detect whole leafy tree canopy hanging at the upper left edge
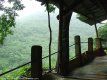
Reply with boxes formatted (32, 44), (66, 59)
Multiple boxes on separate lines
(0, 0), (24, 44)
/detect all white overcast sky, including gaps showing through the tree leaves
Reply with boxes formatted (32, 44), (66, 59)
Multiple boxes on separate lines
(0, 0), (58, 18)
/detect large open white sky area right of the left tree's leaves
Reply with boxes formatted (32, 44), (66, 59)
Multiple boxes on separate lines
(18, 0), (45, 16)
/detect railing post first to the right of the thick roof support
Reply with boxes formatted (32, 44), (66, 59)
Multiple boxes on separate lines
(75, 35), (82, 65)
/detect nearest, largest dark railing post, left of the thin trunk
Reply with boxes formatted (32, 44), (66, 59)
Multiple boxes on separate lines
(31, 45), (42, 80)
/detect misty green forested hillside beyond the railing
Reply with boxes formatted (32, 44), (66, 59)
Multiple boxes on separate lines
(0, 7), (102, 78)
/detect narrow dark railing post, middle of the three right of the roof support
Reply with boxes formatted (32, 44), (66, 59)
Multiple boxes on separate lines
(88, 38), (94, 60)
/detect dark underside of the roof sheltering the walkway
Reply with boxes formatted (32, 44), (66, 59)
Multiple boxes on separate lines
(37, 0), (107, 25)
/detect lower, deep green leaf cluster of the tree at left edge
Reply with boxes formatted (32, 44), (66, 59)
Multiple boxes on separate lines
(0, 14), (15, 44)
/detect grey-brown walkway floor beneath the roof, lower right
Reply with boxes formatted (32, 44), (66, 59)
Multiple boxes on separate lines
(43, 56), (107, 80)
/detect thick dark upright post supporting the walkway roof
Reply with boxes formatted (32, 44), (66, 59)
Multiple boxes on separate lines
(57, 0), (72, 76)
